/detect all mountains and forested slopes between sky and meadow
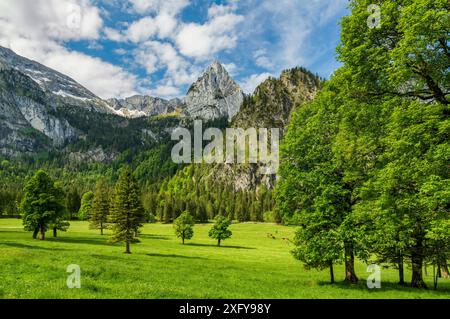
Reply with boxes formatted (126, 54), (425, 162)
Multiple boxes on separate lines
(0, 47), (322, 222)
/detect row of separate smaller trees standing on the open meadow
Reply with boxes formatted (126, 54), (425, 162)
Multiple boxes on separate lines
(21, 167), (232, 253)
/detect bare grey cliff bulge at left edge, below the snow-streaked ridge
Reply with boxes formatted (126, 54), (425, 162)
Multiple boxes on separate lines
(0, 64), (76, 156)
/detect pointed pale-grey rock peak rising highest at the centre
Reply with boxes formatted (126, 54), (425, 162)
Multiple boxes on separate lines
(184, 61), (244, 121)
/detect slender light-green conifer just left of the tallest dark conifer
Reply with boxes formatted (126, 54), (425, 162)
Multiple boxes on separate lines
(90, 178), (110, 235)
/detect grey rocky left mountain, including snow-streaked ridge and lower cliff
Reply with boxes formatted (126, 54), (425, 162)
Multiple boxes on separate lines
(0, 47), (117, 155)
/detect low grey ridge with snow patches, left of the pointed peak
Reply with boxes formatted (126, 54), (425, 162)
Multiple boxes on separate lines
(107, 95), (183, 118)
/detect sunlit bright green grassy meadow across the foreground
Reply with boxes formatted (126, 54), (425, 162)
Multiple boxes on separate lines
(0, 219), (450, 298)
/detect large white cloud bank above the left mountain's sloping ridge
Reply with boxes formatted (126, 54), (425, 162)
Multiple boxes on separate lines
(0, 0), (137, 98)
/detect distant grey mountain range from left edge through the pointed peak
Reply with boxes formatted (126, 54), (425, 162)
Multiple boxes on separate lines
(0, 47), (243, 159)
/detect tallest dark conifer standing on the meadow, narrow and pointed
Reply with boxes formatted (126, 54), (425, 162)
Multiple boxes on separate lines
(110, 167), (144, 254)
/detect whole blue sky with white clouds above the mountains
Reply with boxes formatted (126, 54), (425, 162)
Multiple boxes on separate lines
(0, 0), (347, 98)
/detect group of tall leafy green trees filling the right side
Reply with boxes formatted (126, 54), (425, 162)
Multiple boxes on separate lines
(276, 0), (450, 287)
